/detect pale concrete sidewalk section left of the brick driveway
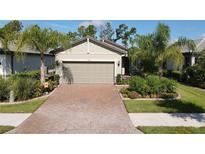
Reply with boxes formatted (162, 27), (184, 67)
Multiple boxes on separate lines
(0, 113), (31, 127)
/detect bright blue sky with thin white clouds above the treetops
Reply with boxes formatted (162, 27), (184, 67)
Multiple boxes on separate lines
(0, 20), (205, 40)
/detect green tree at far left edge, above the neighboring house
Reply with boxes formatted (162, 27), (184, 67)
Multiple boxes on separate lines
(0, 20), (23, 51)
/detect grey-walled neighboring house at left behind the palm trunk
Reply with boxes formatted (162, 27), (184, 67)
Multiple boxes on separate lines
(0, 45), (55, 76)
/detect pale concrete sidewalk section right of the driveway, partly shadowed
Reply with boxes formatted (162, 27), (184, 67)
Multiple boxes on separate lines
(129, 113), (205, 127)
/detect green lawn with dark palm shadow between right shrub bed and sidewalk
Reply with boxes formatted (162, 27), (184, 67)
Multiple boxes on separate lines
(124, 83), (205, 113)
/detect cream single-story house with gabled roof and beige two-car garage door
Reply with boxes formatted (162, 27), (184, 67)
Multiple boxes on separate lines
(56, 37), (128, 84)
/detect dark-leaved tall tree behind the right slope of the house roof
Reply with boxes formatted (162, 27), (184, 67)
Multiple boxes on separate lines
(114, 24), (136, 47)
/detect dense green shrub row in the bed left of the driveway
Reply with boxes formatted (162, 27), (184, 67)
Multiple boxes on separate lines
(0, 71), (59, 100)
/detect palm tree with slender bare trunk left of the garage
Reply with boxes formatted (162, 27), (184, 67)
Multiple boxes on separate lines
(16, 25), (68, 83)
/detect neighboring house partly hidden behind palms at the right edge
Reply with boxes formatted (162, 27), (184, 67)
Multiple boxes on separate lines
(167, 38), (205, 70)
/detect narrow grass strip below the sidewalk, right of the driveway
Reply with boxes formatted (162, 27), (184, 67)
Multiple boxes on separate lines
(137, 126), (205, 134)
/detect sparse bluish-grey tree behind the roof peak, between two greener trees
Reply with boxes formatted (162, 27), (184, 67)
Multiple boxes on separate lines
(99, 22), (114, 41)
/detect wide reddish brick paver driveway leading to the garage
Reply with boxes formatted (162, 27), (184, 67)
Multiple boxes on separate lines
(12, 84), (138, 133)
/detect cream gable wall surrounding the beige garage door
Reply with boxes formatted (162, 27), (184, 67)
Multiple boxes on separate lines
(56, 42), (122, 83)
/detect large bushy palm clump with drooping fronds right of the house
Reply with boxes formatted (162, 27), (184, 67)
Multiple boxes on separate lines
(133, 23), (195, 76)
